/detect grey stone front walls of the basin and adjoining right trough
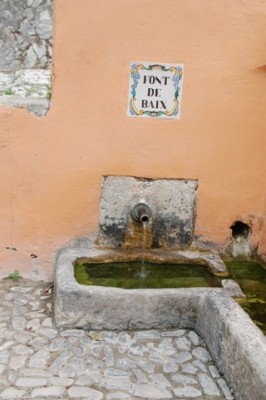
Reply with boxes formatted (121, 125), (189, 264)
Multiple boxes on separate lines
(54, 248), (266, 400)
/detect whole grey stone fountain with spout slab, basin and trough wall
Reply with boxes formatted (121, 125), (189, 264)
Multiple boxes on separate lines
(54, 176), (266, 400)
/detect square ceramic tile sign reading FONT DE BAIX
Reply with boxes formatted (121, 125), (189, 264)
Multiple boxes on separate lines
(128, 62), (184, 119)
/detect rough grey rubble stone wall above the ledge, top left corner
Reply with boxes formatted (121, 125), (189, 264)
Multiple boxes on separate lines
(0, 0), (52, 70)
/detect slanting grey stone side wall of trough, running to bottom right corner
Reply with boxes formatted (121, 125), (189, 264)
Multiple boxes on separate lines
(196, 293), (266, 400)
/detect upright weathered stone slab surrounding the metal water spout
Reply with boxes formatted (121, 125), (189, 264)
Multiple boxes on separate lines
(98, 176), (197, 248)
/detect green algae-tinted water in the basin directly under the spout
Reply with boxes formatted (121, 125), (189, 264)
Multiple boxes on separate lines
(74, 261), (221, 289)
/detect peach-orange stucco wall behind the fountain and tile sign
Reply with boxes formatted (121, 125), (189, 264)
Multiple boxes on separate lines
(0, 0), (266, 278)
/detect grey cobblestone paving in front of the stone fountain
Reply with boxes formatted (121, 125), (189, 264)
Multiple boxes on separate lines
(0, 279), (234, 400)
